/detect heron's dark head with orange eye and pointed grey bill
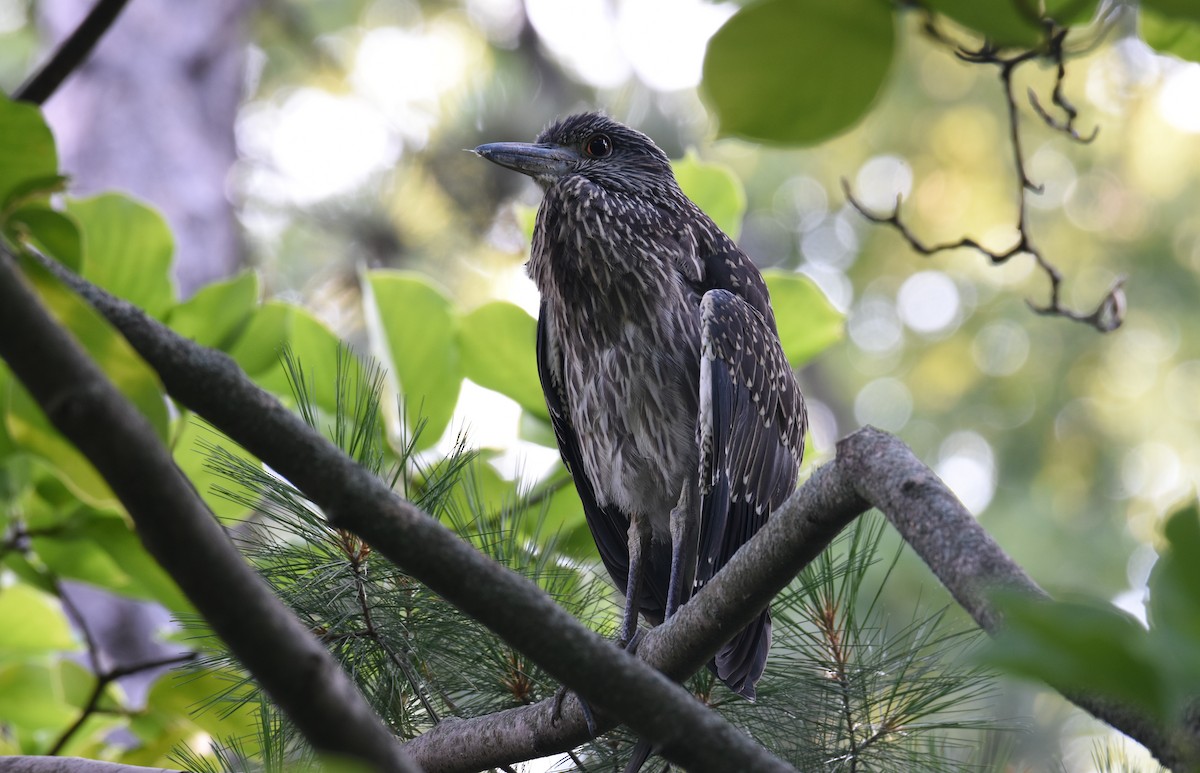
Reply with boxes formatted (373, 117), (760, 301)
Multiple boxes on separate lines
(475, 113), (679, 198)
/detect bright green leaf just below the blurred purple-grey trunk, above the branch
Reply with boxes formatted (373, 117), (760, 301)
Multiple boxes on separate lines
(67, 193), (175, 319)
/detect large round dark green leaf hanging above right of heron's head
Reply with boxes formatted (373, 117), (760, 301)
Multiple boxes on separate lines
(701, 0), (895, 145)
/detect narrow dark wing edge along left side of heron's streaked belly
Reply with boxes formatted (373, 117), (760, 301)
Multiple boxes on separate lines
(538, 302), (670, 621)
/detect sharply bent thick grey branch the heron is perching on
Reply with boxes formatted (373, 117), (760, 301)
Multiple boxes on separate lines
(407, 427), (1196, 771)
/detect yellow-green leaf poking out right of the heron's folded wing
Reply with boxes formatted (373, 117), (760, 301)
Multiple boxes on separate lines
(762, 271), (846, 367)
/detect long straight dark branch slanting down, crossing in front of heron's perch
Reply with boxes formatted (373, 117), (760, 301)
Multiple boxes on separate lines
(28, 259), (792, 771)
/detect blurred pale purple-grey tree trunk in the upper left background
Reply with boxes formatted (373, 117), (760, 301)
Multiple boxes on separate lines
(38, 0), (253, 296)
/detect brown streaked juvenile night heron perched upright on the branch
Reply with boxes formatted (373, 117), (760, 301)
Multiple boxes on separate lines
(475, 113), (805, 699)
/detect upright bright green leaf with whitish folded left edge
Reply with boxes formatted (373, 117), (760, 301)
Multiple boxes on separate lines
(364, 271), (462, 448)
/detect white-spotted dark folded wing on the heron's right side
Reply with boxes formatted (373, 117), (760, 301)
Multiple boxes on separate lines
(696, 289), (805, 583)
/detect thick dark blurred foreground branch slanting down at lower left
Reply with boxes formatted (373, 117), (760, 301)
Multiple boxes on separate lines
(0, 245), (418, 771)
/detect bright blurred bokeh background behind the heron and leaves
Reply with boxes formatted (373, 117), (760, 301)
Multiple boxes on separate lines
(0, 0), (1200, 771)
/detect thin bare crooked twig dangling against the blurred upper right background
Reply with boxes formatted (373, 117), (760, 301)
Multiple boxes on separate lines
(841, 13), (1126, 332)
